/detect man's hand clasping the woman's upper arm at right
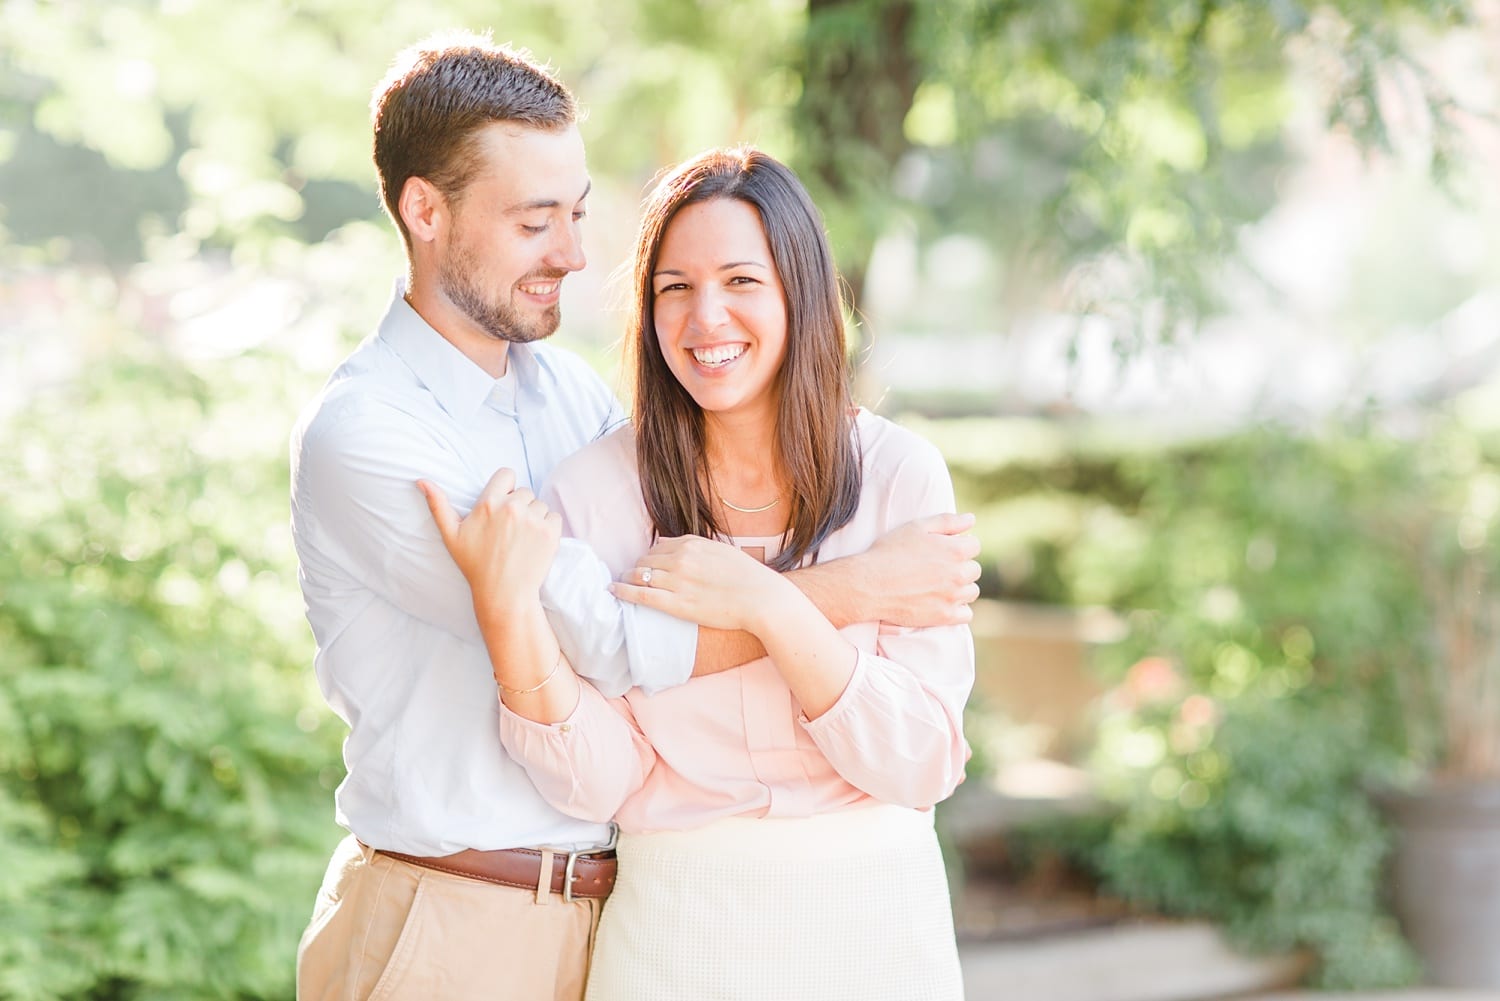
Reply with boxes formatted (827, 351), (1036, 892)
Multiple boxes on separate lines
(854, 515), (980, 627)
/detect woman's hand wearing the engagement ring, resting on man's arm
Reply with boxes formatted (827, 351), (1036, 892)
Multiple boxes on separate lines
(611, 536), (806, 635)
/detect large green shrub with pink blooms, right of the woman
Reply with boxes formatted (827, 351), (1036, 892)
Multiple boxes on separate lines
(990, 419), (1500, 987)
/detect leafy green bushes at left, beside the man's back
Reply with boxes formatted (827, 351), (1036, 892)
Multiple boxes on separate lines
(0, 345), (339, 1001)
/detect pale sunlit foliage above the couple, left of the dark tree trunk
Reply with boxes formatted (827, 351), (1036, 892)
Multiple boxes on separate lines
(0, 0), (800, 266)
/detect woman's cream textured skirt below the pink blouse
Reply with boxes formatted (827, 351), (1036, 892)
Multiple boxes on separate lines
(588, 804), (963, 1001)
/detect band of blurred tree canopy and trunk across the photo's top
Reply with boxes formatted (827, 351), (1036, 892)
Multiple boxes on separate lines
(0, 0), (1472, 328)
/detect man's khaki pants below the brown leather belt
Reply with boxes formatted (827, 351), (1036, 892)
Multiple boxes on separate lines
(297, 836), (603, 1001)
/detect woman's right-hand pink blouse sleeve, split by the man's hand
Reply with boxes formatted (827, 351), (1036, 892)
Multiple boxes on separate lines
(801, 440), (974, 807)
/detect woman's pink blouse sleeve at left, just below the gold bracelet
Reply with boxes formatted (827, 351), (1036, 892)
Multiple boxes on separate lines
(500, 681), (657, 824)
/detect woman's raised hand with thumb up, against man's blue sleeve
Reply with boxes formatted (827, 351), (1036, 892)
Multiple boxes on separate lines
(417, 468), (563, 606)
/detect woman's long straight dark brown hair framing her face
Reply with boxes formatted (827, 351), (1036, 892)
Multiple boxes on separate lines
(626, 147), (860, 570)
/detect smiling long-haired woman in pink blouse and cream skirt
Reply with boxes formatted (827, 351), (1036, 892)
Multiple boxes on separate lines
(438, 149), (974, 1001)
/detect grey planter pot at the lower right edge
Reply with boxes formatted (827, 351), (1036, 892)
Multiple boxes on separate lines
(1377, 780), (1500, 989)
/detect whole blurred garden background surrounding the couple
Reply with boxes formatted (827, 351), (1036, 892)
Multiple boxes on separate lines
(0, 0), (1500, 999)
